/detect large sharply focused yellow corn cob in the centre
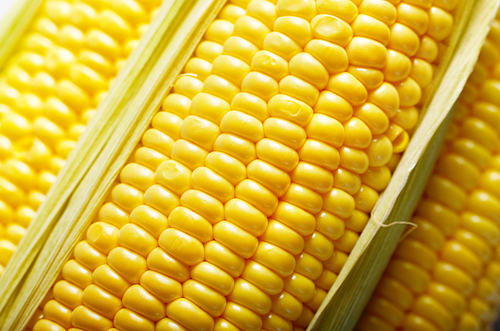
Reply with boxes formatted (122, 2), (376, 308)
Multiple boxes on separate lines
(19, 0), (456, 330)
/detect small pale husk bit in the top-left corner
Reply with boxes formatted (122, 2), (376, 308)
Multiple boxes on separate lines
(0, 0), (43, 70)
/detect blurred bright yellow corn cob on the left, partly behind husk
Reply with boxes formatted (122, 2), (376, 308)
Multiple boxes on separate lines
(0, 0), (160, 276)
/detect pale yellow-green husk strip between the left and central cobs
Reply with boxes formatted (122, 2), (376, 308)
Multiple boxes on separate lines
(0, 0), (224, 330)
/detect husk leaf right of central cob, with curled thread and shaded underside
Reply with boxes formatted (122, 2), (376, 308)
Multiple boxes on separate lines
(307, 0), (499, 331)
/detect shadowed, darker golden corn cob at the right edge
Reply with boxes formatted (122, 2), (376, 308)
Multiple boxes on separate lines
(358, 10), (500, 331)
